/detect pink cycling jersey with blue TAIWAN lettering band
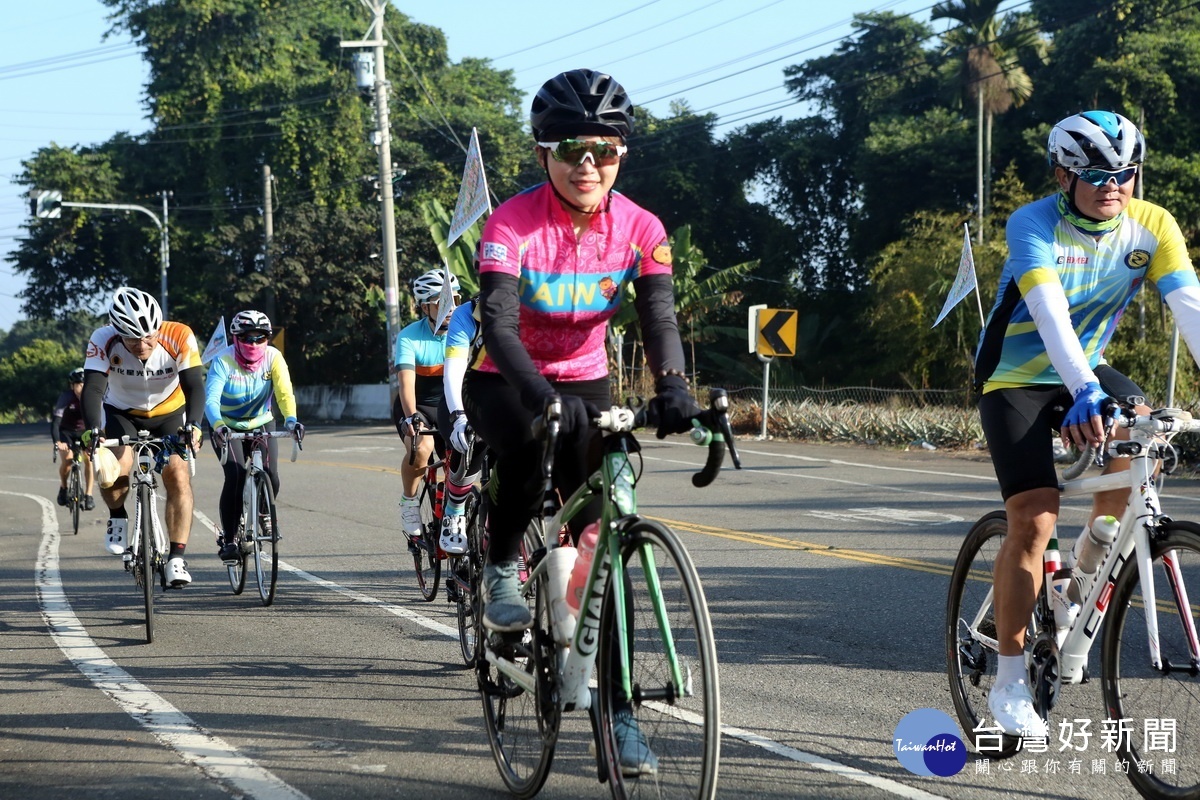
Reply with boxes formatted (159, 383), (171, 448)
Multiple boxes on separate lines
(479, 184), (671, 380)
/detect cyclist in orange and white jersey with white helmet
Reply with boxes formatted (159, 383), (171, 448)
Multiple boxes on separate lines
(83, 287), (204, 587)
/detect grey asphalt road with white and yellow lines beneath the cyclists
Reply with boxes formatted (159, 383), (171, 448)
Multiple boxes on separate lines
(0, 426), (1200, 800)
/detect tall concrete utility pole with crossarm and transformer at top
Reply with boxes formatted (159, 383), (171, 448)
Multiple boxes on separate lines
(341, 0), (400, 390)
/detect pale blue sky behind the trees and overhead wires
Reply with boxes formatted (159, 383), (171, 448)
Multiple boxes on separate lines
(0, 0), (984, 330)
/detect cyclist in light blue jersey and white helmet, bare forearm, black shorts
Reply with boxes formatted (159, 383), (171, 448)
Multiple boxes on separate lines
(391, 270), (458, 541)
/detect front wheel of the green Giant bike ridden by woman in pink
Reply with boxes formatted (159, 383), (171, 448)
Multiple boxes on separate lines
(595, 519), (721, 799)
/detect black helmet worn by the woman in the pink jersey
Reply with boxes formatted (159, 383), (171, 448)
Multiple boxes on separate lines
(529, 70), (634, 142)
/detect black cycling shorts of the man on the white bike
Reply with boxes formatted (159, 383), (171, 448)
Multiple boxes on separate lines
(979, 365), (1144, 500)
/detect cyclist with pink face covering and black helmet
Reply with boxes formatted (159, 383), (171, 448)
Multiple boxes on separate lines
(204, 311), (304, 563)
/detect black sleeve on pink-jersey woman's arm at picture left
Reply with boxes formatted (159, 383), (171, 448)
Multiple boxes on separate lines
(479, 272), (553, 414)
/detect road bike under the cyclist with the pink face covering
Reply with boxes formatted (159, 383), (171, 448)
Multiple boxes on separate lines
(217, 428), (304, 606)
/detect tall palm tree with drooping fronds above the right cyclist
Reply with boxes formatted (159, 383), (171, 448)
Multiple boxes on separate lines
(932, 0), (1046, 242)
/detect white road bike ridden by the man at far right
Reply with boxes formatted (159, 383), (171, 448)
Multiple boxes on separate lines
(946, 397), (1200, 798)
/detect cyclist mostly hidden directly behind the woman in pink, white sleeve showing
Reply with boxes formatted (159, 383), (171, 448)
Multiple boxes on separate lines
(438, 295), (484, 555)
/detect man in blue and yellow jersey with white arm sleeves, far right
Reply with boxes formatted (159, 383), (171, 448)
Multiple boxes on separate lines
(976, 112), (1200, 736)
